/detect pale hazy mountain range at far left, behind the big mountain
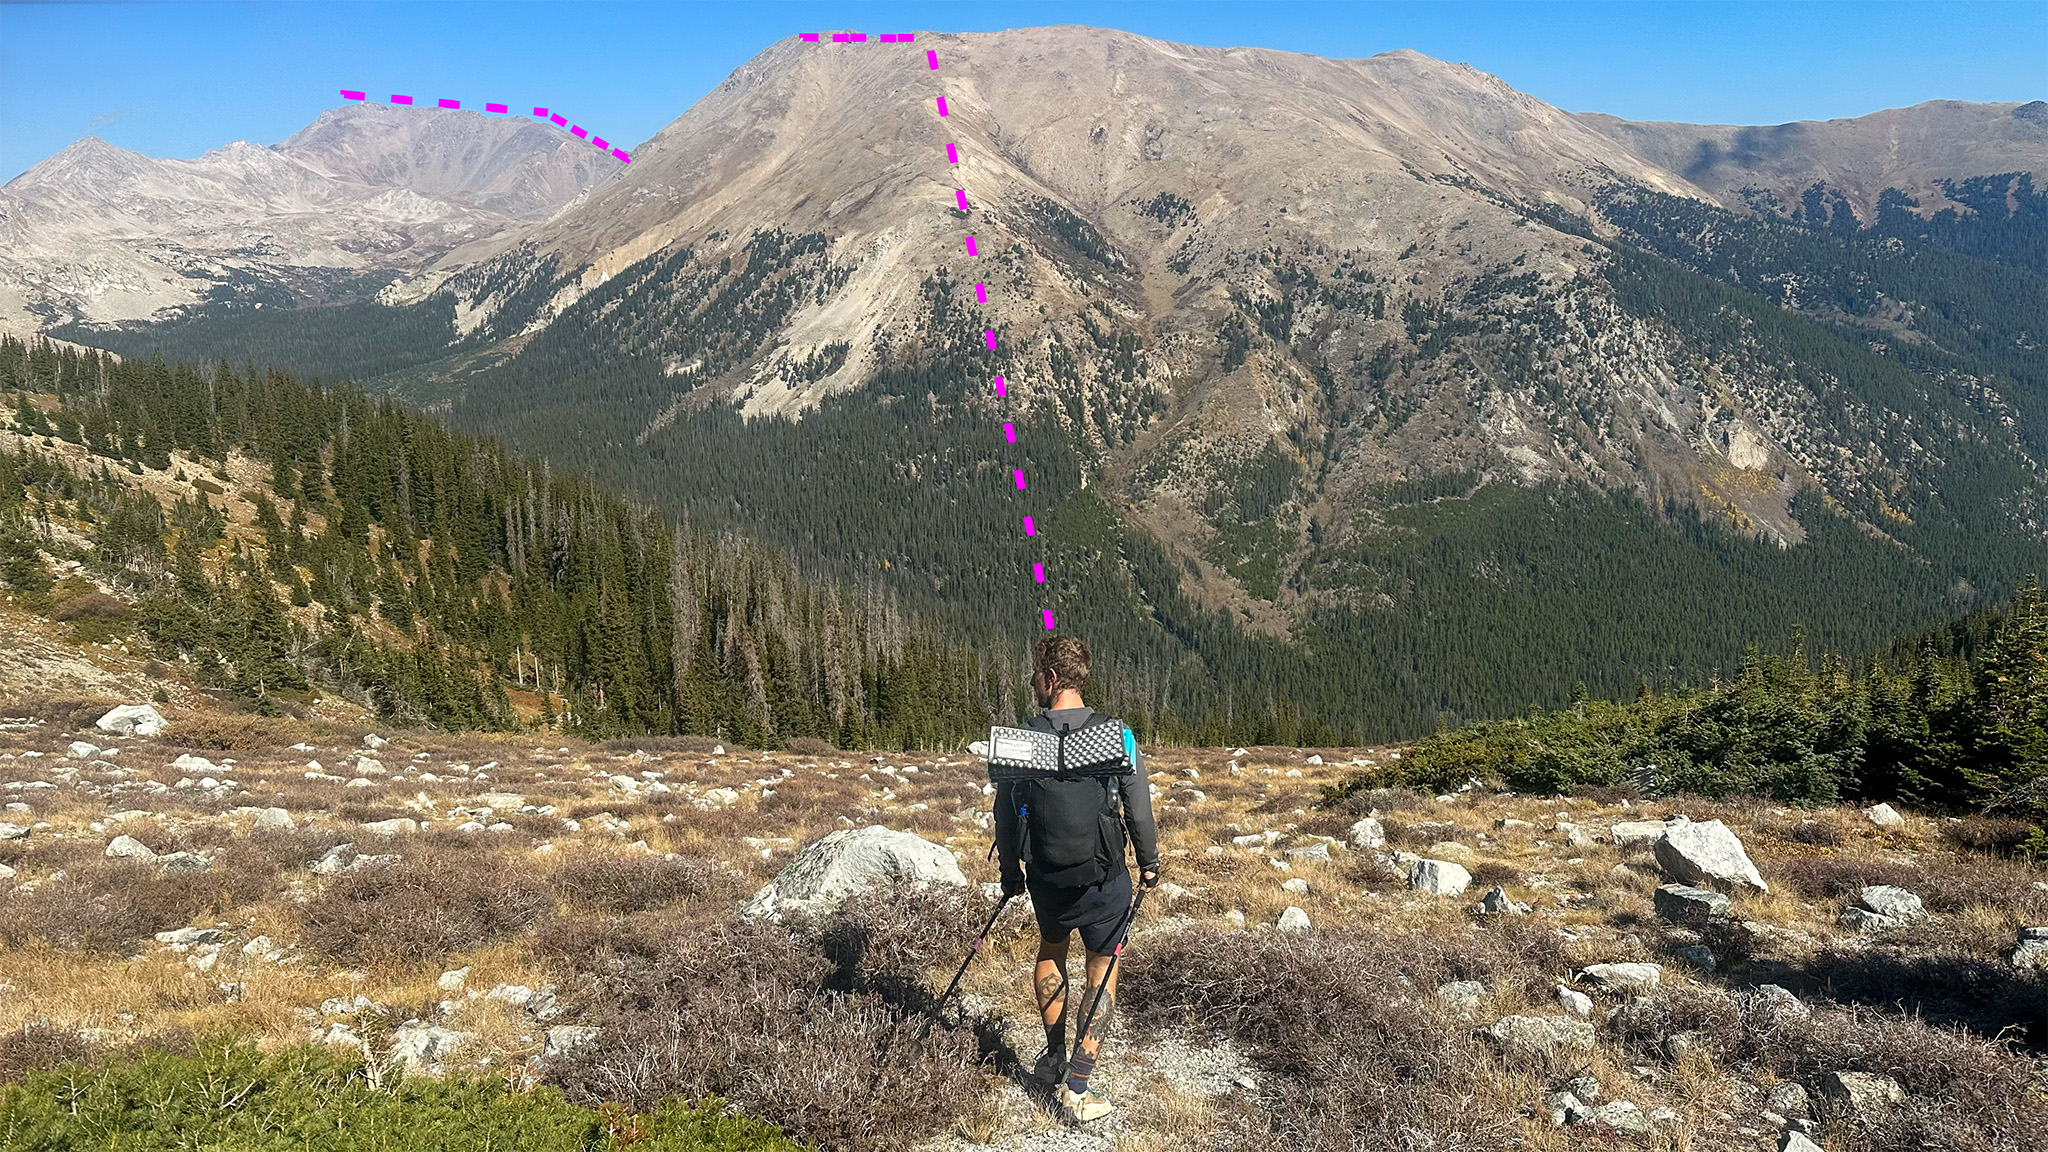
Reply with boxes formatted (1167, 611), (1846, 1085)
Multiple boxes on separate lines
(0, 105), (623, 328)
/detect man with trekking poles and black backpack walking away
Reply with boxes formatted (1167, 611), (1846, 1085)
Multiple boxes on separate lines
(995, 635), (1159, 1123)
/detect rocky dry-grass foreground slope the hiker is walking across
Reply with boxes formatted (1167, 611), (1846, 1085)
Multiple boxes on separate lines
(0, 701), (2048, 1152)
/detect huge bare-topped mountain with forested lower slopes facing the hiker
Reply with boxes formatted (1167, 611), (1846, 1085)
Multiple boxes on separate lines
(8, 27), (2048, 728)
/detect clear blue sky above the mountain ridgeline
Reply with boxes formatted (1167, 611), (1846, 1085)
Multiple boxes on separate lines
(0, 0), (2048, 180)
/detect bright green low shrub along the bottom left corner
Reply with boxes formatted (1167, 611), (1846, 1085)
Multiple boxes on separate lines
(0, 1039), (797, 1152)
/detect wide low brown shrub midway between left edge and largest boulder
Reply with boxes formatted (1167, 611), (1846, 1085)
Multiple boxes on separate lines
(299, 845), (555, 963)
